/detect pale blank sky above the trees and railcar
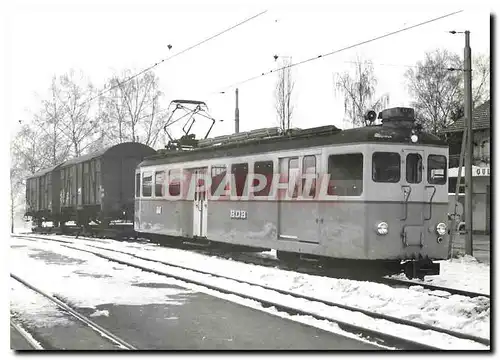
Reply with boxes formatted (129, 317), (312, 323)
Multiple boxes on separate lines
(3, 1), (494, 143)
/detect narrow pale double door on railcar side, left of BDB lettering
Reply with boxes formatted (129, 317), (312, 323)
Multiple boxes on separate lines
(191, 168), (208, 237)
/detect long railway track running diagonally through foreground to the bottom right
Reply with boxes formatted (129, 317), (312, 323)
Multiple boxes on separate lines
(11, 236), (490, 350)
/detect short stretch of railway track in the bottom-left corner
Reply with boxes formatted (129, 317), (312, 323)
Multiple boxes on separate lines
(10, 273), (136, 350)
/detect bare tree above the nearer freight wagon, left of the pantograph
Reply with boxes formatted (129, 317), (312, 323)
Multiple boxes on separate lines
(103, 70), (167, 146)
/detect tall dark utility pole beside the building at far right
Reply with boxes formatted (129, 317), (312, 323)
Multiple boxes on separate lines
(464, 31), (474, 256)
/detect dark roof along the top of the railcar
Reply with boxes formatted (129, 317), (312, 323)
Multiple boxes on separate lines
(139, 125), (448, 166)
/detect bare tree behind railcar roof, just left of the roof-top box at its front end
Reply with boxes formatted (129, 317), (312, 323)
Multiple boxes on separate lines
(334, 57), (389, 127)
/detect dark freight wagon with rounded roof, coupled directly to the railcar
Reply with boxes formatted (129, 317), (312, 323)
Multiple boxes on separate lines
(60, 142), (156, 225)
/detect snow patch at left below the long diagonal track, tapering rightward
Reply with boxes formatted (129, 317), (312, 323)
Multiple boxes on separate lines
(10, 238), (384, 343)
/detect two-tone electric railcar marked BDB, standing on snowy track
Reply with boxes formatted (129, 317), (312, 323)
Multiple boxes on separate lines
(134, 108), (449, 277)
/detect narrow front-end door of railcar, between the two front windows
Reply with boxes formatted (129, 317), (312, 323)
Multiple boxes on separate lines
(401, 149), (428, 247)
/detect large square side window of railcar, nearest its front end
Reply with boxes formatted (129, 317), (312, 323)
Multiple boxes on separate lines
(328, 153), (363, 196)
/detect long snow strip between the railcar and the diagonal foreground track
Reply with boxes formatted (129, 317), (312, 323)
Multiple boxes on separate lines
(9, 237), (490, 349)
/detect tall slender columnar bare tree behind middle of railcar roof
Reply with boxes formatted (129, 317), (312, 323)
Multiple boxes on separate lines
(274, 60), (295, 131)
